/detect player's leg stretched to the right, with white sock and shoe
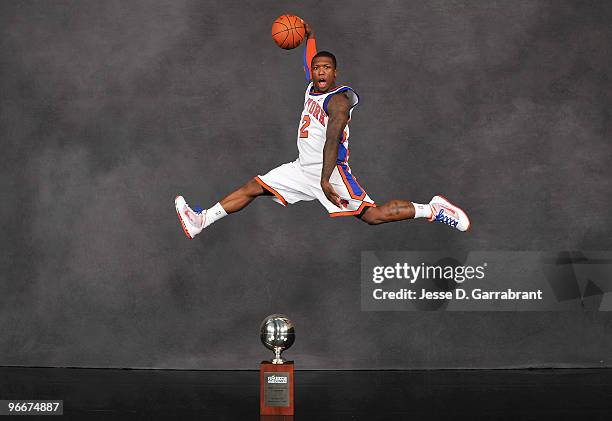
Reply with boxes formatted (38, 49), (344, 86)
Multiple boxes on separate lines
(356, 195), (470, 231)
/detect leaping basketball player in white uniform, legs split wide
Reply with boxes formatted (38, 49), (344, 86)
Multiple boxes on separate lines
(175, 21), (470, 238)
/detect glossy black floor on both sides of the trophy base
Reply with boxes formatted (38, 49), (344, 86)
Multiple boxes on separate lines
(0, 367), (612, 421)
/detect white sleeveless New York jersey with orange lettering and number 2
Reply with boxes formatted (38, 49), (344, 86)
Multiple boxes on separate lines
(297, 82), (359, 171)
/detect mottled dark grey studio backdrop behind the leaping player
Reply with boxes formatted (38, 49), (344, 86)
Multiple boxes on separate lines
(0, 0), (612, 369)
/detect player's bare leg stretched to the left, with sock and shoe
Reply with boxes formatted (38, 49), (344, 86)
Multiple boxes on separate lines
(174, 179), (271, 238)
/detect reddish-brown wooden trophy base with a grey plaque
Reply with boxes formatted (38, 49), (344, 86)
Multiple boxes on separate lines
(259, 361), (294, 415)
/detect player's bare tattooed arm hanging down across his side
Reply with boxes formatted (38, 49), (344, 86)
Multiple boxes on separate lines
(321, 94), (351, 207)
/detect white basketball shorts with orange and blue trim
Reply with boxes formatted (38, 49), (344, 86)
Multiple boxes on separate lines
(255, 161), (376, 217)
